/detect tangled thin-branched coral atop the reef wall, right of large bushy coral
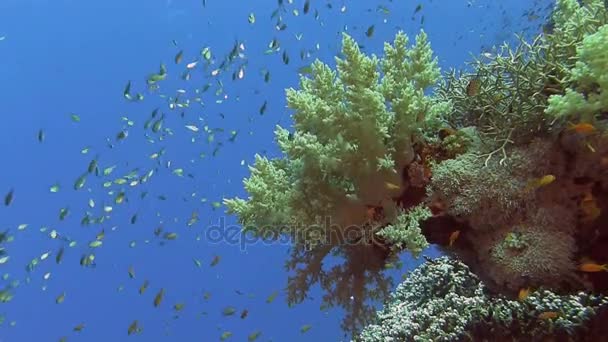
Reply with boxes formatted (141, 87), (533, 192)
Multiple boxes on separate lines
(437, 0), (608, 148)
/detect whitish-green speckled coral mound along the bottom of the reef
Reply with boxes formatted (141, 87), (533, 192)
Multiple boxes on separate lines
(355, 257), (608, 342)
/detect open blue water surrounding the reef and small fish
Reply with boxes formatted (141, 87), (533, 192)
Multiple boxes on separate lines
(0, 0), (550, 341)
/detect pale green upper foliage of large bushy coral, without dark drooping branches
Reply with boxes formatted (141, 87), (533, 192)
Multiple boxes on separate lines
(224, 32), (442, 254)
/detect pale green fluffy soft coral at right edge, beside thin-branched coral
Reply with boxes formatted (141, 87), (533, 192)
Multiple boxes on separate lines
(547, 25), (608, 120)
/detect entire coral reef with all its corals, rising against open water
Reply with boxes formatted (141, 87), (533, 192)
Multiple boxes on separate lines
(224, 0), (608, 340)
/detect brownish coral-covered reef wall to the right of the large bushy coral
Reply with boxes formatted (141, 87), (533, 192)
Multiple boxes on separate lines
(422, 0), (608, 295)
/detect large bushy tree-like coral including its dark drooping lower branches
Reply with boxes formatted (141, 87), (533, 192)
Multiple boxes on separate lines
(224, 28), (449, 331)
